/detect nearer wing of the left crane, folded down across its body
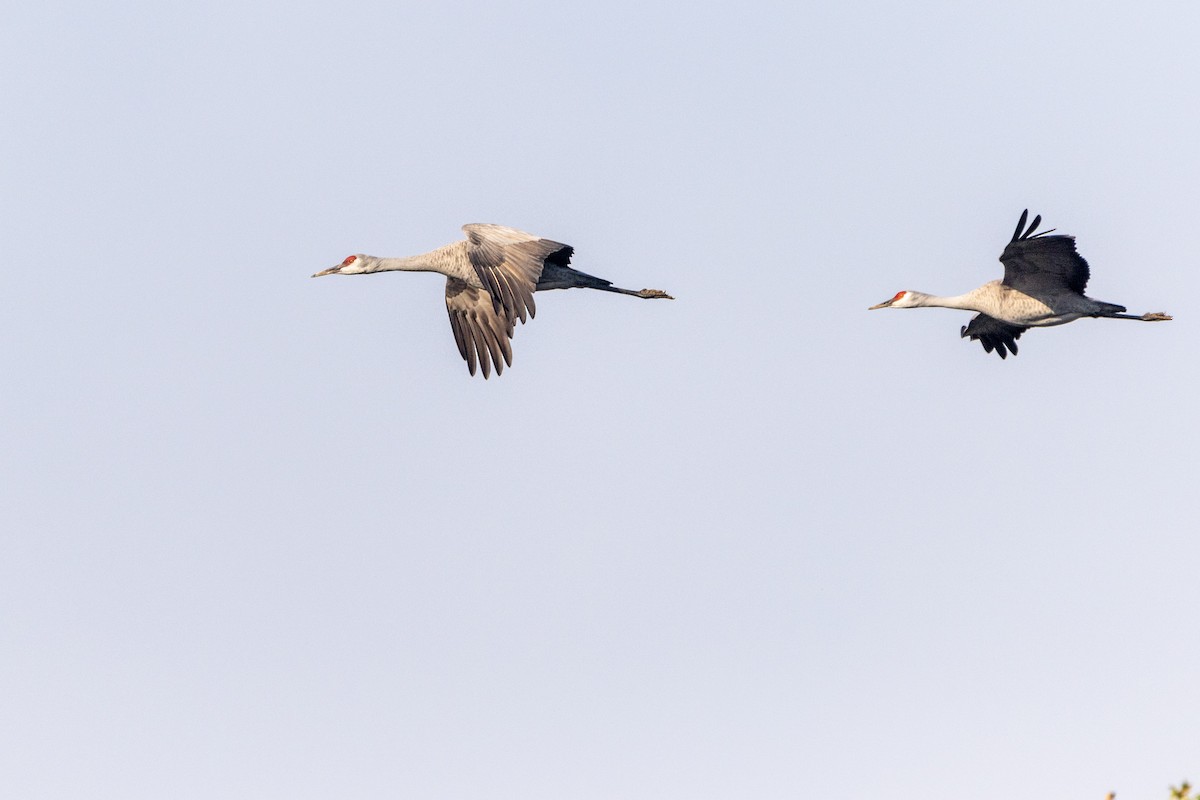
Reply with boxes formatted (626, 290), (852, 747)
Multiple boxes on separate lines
(462, 224), (574, 323)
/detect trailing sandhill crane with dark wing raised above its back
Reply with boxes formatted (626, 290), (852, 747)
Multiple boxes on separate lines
(868, 209), (1170, 359)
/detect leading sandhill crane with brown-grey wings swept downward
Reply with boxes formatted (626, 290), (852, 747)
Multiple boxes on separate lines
(312, 224), (673, 378)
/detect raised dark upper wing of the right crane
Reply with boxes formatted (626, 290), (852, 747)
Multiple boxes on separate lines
(1000, 209), (1090, 295)
